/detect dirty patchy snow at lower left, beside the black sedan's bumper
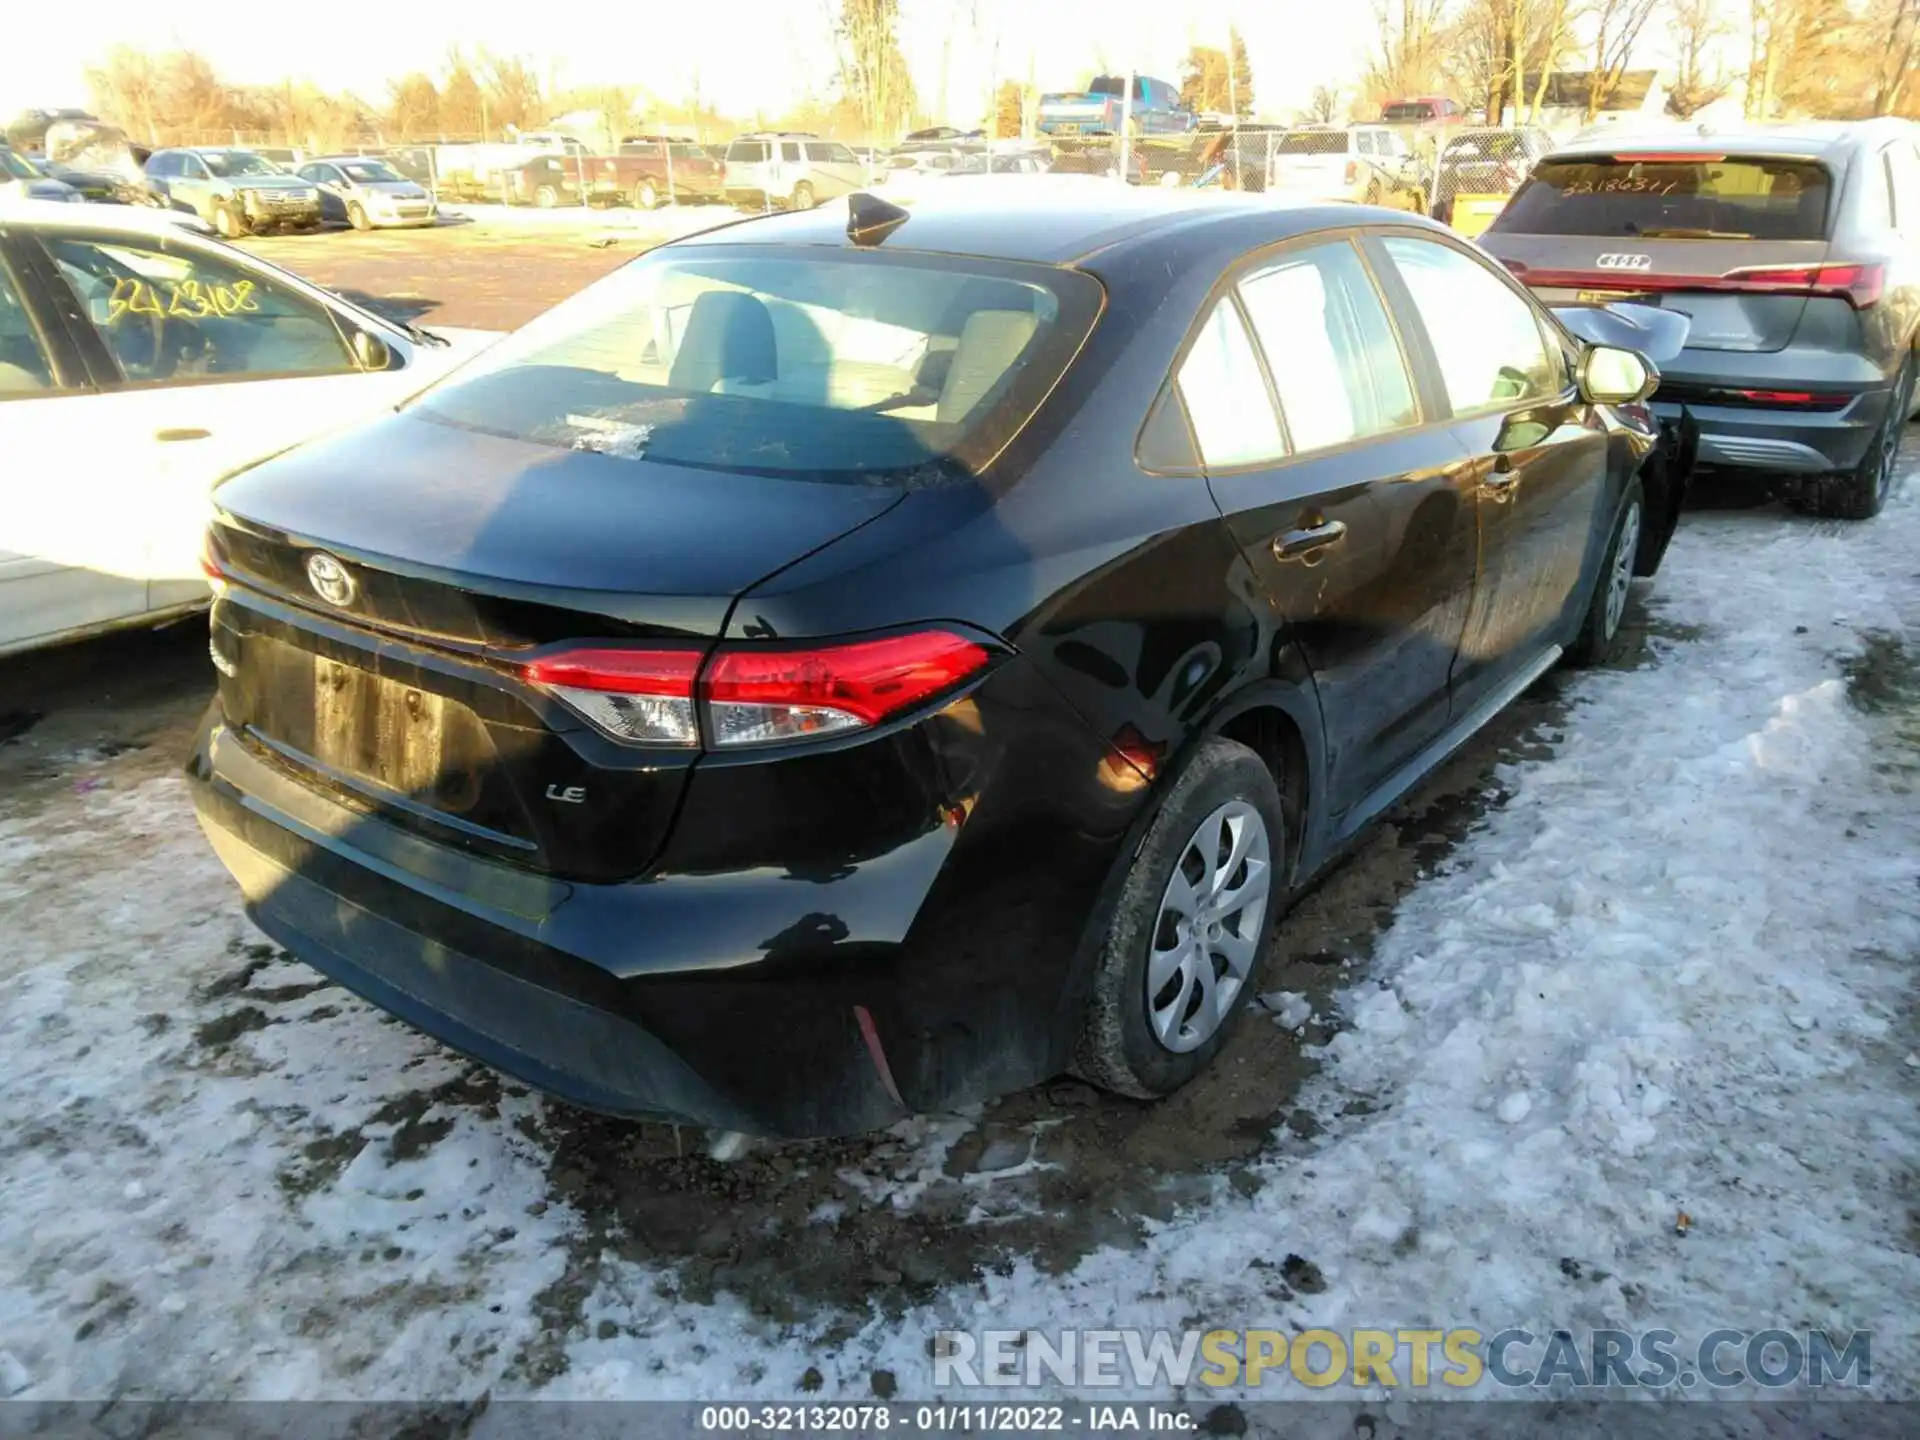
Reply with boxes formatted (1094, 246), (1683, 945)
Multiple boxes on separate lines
(0, 778), (566, 1398)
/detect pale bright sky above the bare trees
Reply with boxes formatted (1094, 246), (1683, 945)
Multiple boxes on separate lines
(0, 0), (1371, 123)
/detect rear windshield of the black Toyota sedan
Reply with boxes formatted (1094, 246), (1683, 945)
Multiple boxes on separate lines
(417, 246), (1102, 484)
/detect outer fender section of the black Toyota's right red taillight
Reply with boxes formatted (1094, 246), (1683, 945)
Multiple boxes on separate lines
(701, 630), (987, 745)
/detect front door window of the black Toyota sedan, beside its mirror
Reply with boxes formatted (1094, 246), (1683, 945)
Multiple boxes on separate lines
(1382, 236), (1567, 415)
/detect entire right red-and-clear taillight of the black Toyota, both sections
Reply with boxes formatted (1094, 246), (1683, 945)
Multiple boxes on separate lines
(520, 630), (993, 749)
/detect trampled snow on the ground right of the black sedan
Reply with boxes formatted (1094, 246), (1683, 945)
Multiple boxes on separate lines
(559, 480), (1920, 1398)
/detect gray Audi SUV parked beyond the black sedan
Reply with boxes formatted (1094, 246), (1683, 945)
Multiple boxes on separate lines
(1480, 119), (1920, 520)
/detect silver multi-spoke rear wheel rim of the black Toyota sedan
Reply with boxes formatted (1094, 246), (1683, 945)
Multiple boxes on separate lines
(1144, 801), (1273, 1054)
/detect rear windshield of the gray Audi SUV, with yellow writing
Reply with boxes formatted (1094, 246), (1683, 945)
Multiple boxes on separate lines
(1494, 156), (1832, 240)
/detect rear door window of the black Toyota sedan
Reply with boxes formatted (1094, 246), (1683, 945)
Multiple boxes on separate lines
(1240, 244), (1417, 453)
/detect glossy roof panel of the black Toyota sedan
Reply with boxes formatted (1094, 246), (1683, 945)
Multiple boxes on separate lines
(666, 184), (1442, 265)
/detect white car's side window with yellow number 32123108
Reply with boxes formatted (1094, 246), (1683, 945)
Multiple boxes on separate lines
(46, 236), (359, 384)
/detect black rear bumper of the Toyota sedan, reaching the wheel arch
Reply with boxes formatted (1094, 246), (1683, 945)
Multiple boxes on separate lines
(186, 664), (1144, 1137)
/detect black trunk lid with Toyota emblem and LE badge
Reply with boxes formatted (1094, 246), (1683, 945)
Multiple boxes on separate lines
(211, 413), (900, 881)
